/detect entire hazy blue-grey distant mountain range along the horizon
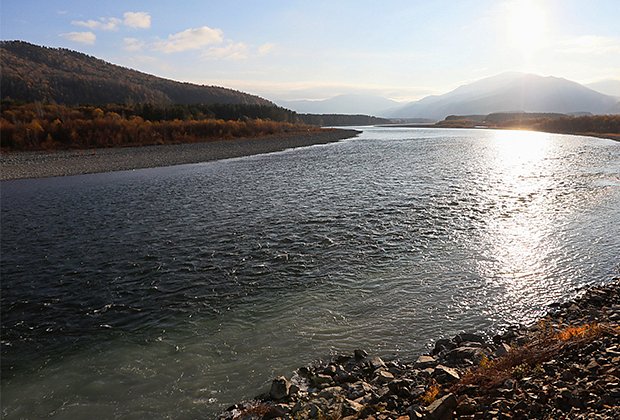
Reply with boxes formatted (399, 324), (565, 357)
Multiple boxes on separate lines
(275, 72), (620, 120)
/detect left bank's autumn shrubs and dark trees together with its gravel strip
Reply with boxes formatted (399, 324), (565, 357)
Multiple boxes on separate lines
(0, 101), (359, 180)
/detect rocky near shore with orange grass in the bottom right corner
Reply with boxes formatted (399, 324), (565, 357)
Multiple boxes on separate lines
(220, 279), (620, 420)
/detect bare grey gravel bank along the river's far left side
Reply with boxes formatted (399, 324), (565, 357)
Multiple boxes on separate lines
(0, 129), (359, 180)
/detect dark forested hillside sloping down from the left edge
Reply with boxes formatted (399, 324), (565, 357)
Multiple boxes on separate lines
(0, 41), (274, 105)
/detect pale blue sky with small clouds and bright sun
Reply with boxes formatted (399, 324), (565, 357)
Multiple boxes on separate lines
(0, 0), (620, 101)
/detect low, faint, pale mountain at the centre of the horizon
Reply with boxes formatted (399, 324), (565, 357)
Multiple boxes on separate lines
(274, 94), (402, 116)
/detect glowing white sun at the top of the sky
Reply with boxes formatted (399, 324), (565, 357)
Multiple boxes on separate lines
(505, 0), (547, 56)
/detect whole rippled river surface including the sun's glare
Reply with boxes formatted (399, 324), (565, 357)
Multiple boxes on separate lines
(1, 128), (620, 419)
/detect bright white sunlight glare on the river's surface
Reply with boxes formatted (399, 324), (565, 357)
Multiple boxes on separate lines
(480, 130), (554, 318)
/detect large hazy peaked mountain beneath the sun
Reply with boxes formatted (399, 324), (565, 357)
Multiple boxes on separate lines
(388, 72), (618, 120)
